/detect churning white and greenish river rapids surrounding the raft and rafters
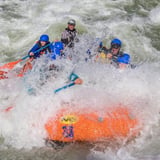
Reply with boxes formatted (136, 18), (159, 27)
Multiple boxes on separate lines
(0, 0), (160, 160)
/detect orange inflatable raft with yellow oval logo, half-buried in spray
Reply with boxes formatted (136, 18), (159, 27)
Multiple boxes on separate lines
(45, 107), (138, 142)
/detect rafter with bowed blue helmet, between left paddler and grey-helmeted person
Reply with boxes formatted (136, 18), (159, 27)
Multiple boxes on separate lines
(50, 41), (64, 60)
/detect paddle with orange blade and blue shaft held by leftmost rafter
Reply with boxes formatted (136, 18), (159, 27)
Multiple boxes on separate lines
(0, 43), (52, 69)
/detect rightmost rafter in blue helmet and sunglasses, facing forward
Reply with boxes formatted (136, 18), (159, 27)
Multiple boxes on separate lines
(98, 38), (130, 68)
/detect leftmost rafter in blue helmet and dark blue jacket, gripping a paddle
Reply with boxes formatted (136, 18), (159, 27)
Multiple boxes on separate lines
(19, 34), (51, 76)
